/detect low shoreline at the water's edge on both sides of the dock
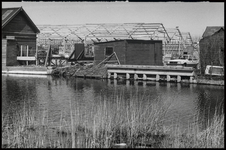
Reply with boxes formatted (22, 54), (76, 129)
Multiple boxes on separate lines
(2, 65), (224, 86)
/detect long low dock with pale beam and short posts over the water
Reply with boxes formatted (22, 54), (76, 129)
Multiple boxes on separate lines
(107, 64), (197, 83)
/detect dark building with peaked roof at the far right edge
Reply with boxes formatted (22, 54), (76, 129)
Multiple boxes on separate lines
(199, 26), (224, 74)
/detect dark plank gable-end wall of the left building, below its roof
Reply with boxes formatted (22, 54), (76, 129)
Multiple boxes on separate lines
(2, 9), (37, 66)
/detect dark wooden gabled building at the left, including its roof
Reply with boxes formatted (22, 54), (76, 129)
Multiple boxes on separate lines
(2, 7), (40, 67)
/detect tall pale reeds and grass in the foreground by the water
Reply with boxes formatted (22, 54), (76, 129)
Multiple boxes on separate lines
(2, 92), (224, 148)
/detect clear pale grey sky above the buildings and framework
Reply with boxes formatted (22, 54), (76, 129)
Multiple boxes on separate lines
(2, 2), (224, 37)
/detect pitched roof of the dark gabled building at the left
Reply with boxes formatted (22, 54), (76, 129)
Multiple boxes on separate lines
(2, 7), (40, 33)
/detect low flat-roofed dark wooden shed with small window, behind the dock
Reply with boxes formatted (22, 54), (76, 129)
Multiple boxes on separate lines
(94, 40), (163, 66)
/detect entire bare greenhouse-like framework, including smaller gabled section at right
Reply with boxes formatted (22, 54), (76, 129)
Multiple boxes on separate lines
(37, 23), (193, 58)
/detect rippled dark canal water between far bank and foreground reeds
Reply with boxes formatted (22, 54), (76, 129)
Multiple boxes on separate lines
(2, 74), (224, 134)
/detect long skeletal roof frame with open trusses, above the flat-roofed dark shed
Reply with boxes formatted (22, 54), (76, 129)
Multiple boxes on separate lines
(37, 23), (170, 43)
